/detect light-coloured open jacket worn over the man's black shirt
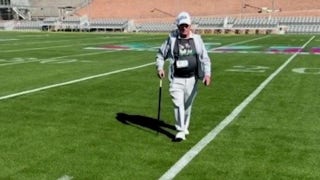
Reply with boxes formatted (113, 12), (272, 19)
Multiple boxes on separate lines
(156, 31), (211, 80)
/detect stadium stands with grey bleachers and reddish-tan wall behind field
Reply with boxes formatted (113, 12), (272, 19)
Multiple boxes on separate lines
(0, 0), (320, 34)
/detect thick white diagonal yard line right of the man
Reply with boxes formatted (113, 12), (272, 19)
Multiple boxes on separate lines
(159, 36), (315, 180)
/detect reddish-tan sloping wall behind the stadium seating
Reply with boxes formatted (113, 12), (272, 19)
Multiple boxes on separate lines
(78, 0), (320, 19)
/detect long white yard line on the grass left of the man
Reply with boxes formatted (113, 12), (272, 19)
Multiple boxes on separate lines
(0, 62), (154, 101)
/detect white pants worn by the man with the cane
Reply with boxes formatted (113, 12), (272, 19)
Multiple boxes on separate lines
(169, 77), (197, 131)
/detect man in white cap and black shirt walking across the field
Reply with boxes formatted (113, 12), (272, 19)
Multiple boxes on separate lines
(156, 12), (211, 141)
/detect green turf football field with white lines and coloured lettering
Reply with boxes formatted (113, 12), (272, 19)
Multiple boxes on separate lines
(0, 32), (320, 180)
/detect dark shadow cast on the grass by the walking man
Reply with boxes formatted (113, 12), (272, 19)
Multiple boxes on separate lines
(116, 113), (175, 139)
